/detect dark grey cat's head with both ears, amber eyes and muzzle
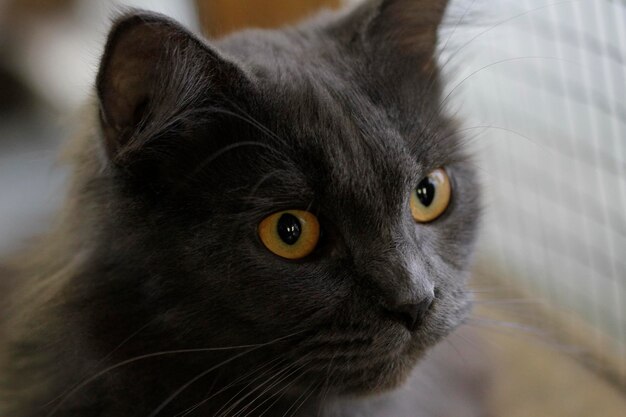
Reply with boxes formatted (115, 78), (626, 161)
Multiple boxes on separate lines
(86, 0), (478, 392)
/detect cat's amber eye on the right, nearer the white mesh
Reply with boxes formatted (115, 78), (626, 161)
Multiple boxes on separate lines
(411, 168), (452, 223)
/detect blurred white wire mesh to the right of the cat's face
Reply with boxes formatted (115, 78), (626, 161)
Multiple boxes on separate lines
(441, 0), (626, 384)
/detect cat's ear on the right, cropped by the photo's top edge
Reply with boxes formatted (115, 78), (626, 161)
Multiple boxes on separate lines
(361, 0), (448, 70)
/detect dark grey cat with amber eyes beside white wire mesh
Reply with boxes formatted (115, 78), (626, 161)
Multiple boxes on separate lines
(0, 0), (485, 417)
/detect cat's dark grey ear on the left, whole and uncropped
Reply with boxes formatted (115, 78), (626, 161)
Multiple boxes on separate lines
(96, 12), (246, 164)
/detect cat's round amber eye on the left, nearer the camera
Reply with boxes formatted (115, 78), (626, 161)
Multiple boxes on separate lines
(259, 210), (320, 259)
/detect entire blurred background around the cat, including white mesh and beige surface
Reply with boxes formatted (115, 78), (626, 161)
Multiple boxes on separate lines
(0, 0), (626, 417)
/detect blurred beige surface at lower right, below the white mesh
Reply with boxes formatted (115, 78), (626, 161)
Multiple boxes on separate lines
(475, 304), (626, 417)
